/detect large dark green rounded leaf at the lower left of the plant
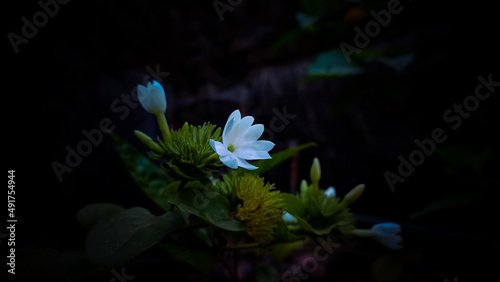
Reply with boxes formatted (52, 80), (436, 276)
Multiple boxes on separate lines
(85, 207), (184, 271)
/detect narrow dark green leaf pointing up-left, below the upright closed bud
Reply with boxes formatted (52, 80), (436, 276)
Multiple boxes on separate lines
(112, 134), (174, 210)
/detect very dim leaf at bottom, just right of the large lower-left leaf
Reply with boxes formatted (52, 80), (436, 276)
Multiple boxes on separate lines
(158, 240), (215, 276)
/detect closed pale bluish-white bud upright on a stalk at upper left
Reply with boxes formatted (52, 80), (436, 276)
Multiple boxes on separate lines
(137, 80), (167, 114)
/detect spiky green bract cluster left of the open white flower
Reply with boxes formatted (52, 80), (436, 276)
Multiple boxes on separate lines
(149, 123), (222, 180)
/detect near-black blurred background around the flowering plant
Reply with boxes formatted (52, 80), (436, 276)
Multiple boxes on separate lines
(1, 0), (500, 281)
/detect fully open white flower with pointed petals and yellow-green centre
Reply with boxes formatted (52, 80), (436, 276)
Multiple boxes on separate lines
(210, 110), (274, 169)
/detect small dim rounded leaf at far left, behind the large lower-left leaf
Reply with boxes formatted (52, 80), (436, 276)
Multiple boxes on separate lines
(76, 203), (124, 229)
